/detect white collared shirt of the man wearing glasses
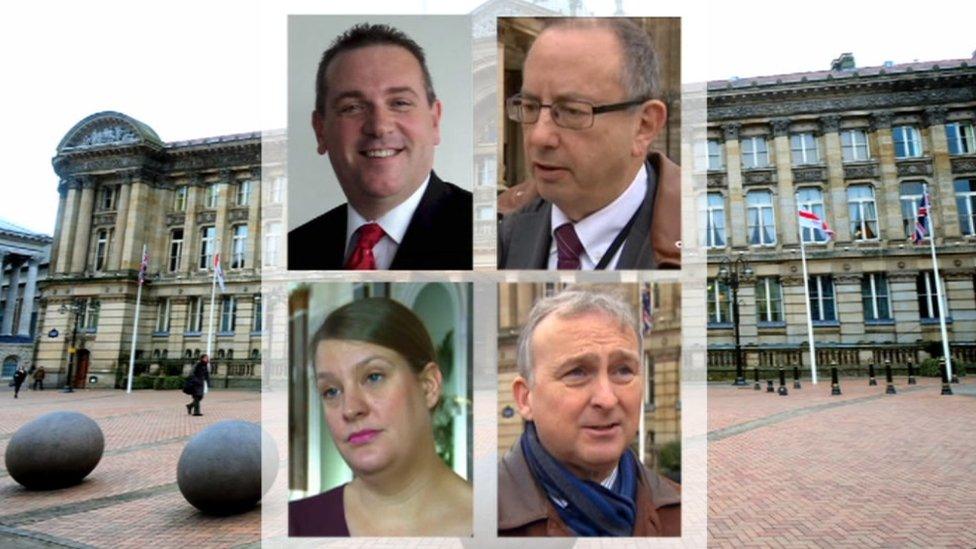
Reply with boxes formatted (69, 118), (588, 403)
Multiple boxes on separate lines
(548, 165), (647, 271)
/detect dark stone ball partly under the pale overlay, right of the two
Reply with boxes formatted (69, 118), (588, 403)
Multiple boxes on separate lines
(176, 419), (278, 515)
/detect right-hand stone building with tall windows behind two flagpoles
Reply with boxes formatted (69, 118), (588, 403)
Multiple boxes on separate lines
(696, 54), (976, 370)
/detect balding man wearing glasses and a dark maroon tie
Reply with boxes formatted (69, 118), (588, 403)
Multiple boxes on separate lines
(498, 18), (681, 270)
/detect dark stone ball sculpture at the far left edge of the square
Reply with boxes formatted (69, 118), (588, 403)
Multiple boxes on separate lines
(4, 411), (105, 490)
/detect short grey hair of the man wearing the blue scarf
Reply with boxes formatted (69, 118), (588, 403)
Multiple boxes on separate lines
(515, 290), (640, 384)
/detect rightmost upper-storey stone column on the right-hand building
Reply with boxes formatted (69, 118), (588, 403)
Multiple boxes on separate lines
(925, 107), (962, 235)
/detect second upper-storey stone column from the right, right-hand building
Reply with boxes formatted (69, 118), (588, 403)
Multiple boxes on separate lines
(871, 112), (905, 241)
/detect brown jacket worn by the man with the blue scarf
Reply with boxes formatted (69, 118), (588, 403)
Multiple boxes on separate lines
(498, 442), (681, 537)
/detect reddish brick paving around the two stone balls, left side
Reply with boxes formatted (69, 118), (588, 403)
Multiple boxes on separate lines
(0, 390), (266, 547)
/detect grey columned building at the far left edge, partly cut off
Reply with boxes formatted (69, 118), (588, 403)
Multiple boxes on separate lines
(0, 220), (51, 380)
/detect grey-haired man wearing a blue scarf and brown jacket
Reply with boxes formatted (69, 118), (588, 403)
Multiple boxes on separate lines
(498, 290), (681, 536)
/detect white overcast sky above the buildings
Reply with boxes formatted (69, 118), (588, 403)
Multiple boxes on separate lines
(0, 0), (976, 234)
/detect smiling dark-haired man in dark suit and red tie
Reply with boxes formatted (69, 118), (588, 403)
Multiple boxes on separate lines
(288, 24), (472, 270)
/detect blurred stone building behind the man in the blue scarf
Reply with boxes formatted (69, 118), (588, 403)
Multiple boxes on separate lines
(498, 282), (681, 464)
